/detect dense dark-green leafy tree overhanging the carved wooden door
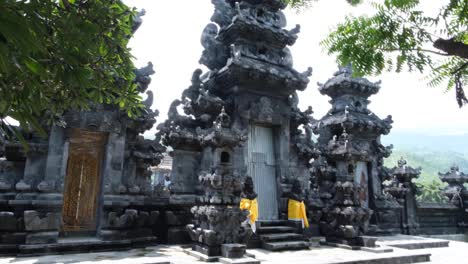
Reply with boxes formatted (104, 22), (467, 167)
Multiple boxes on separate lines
(0, 0), (142, 142)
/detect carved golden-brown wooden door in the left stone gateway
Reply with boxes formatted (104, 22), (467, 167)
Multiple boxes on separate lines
(62, 129), (107, 232)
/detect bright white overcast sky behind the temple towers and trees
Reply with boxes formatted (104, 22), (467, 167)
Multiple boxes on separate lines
(124, 0), (468, 137)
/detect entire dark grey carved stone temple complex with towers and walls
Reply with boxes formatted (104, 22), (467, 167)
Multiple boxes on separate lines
(0, 0), (468, 257)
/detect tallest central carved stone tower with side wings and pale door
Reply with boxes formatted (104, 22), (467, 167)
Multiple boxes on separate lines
(159, 0), (317, 255)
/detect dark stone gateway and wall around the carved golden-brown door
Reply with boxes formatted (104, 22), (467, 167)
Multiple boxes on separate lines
(0, 11), (165, 253)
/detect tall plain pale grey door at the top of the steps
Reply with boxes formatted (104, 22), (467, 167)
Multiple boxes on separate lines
(248, 125), (278, 220)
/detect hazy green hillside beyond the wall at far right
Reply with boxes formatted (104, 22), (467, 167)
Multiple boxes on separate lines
(382, 133), (468, 183)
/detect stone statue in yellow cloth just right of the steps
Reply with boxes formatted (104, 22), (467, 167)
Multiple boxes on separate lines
(288, 180), (309, 228)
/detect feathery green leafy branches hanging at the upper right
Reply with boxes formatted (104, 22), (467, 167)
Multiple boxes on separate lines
(284, 0), (468, 107)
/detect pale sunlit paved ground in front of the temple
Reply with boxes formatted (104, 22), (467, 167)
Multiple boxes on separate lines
(0, 237), (468, 264)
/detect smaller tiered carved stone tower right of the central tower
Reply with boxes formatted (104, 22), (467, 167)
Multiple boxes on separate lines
(315, 67), (392, 245)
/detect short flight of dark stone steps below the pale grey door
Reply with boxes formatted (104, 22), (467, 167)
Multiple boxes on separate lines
(257, 220), (309, 251)
